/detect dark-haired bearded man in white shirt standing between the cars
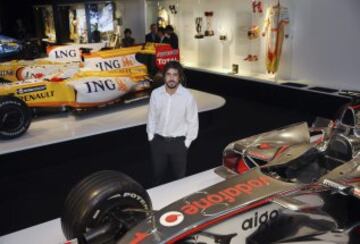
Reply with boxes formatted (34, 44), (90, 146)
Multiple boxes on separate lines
(146, 61), (199, 185)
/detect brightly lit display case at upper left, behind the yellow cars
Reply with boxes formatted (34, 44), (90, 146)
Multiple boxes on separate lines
(33, 0), (123, 46)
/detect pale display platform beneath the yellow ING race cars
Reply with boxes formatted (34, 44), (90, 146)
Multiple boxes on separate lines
(0, 90), (225, 155)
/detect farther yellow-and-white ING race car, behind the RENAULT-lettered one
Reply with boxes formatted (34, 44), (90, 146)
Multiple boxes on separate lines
(0, 45), (156, 82)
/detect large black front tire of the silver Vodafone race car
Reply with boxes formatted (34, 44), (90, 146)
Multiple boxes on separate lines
(61, 170), (152, 243)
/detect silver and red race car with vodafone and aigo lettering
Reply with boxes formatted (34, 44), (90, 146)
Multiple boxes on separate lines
(61, 94), (360, 244)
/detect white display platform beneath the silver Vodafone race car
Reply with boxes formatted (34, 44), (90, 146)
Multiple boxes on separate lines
(0, 169), (223, 244)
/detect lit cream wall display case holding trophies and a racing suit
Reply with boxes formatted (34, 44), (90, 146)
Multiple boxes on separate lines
(146, 0), (293, 81)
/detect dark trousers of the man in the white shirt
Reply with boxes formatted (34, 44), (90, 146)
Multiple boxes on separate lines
(150, 135), (187, 186)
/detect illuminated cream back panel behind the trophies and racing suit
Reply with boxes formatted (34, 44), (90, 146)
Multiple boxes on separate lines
(147, 0), (293, 79)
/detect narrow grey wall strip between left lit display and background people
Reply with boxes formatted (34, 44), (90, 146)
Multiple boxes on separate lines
(120, 0), (148, 43)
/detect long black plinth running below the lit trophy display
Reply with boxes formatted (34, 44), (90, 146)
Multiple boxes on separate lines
(185, 67), (351, 119)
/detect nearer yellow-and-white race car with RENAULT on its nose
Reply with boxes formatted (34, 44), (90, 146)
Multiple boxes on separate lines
(0, 69), (152, 139)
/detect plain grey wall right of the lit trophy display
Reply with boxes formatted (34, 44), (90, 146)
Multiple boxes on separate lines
(292, 0), (360, 90)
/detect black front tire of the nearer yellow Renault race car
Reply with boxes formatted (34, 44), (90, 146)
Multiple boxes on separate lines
(0, 96), (32, 139)
